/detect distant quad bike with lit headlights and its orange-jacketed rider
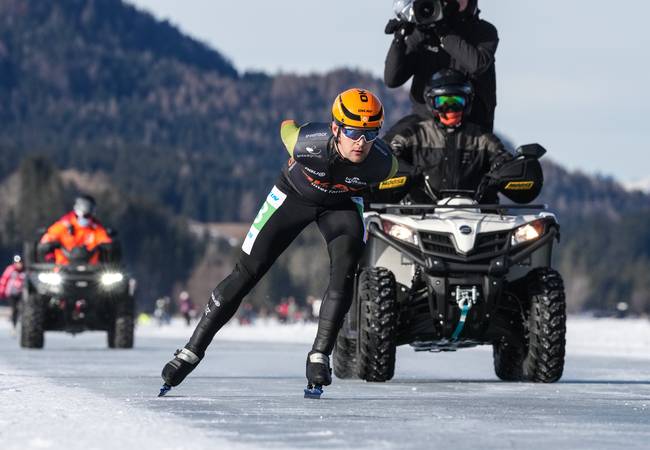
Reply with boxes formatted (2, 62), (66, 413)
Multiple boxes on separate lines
(21, 195), (134, 348)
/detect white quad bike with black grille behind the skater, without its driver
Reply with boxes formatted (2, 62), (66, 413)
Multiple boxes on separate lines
(333, 144), (566, 383)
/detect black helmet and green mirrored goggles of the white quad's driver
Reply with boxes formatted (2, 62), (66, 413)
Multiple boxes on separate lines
(424, 69), (474, 129)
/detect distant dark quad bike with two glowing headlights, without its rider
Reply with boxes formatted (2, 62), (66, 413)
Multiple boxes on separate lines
(20, 234), (135, 348)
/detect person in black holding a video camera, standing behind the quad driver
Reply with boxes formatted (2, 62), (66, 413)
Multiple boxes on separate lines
(384, 0), (499, 132)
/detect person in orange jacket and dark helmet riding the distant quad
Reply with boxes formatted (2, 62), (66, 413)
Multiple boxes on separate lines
(38, 195), (112, 265)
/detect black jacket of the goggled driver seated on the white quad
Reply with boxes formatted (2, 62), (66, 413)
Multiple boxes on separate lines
(383, 118), (513, 202)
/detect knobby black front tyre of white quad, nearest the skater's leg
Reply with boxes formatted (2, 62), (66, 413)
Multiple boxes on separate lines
(357, 267), (398, 382)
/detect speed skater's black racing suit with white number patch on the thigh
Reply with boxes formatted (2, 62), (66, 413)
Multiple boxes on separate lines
(185, 121), (397, 358)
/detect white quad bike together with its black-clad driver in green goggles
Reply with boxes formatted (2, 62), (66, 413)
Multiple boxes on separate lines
(333, 71), (566, 382)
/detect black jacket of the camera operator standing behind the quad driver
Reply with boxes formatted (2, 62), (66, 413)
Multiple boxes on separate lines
(384, 18), (499, 131)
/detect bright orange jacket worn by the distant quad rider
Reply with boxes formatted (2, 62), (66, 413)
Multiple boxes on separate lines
(41, 212), (112, 265)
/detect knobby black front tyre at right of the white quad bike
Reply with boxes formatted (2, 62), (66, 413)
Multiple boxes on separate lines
(523, 268), (566, 383)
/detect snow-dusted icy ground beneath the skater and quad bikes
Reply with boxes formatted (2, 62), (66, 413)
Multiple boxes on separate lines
(0, 317), (650, 450)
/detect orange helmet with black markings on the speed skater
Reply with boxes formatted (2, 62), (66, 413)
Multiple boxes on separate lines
(332, 88), (384, 128)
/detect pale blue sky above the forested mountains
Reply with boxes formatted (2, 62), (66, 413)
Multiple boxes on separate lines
(129, 0), (650, 182)
